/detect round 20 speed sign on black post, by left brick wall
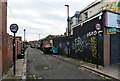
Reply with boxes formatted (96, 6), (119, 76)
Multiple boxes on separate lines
(10, 24), (18, 75)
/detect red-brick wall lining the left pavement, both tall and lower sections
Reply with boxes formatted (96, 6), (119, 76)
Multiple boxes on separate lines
(0, 0), (21, 75)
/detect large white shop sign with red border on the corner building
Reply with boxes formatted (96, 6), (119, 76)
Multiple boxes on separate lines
(106, 12), (120, 28)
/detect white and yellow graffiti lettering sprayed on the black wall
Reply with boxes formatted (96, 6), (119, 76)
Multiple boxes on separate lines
(72, 31), (103, 53)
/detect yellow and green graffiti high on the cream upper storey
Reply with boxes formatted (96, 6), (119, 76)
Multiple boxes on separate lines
(99, 2), (120, 12)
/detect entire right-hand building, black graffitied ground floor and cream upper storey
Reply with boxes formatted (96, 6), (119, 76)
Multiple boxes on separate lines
(54, 0), (120, 66)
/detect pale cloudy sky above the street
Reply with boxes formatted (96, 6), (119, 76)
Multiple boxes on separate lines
(7, 0), (95, 41)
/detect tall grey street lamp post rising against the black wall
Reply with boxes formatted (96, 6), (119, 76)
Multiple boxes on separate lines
(65, 5), (71, 58)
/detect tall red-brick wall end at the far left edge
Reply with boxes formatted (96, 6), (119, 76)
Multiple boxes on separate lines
(1, 2), (8, 73)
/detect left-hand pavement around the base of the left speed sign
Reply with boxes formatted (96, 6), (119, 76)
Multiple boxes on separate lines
(2, 50), (27, 81)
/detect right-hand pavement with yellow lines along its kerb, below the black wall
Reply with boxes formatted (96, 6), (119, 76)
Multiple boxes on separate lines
(53, 55), (120, 80)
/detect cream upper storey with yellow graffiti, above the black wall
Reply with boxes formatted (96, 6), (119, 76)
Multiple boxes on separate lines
(70, 0), (120, 35)
